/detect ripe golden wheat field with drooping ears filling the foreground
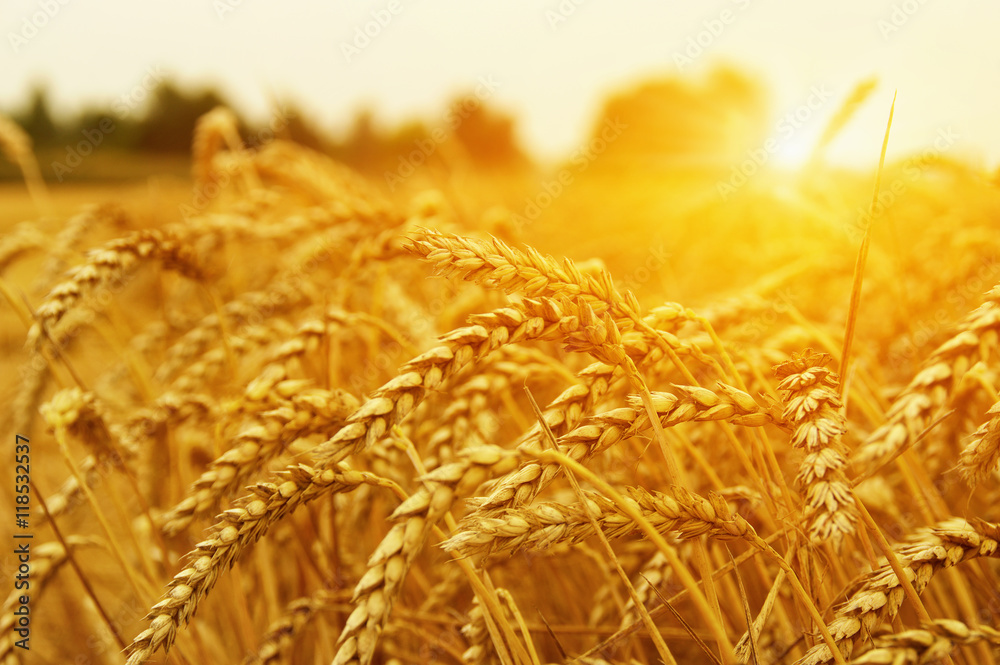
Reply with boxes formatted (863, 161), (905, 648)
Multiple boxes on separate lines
(0, 100), (1000, 665)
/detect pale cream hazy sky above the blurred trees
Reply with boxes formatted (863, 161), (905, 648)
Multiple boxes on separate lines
(0, 0), (1000, 169)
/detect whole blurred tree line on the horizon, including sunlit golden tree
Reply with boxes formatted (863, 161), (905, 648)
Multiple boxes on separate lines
(0, 67), (768, 187)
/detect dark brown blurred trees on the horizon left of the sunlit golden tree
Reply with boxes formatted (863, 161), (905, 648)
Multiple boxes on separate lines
(3, 79), (531, 175)
